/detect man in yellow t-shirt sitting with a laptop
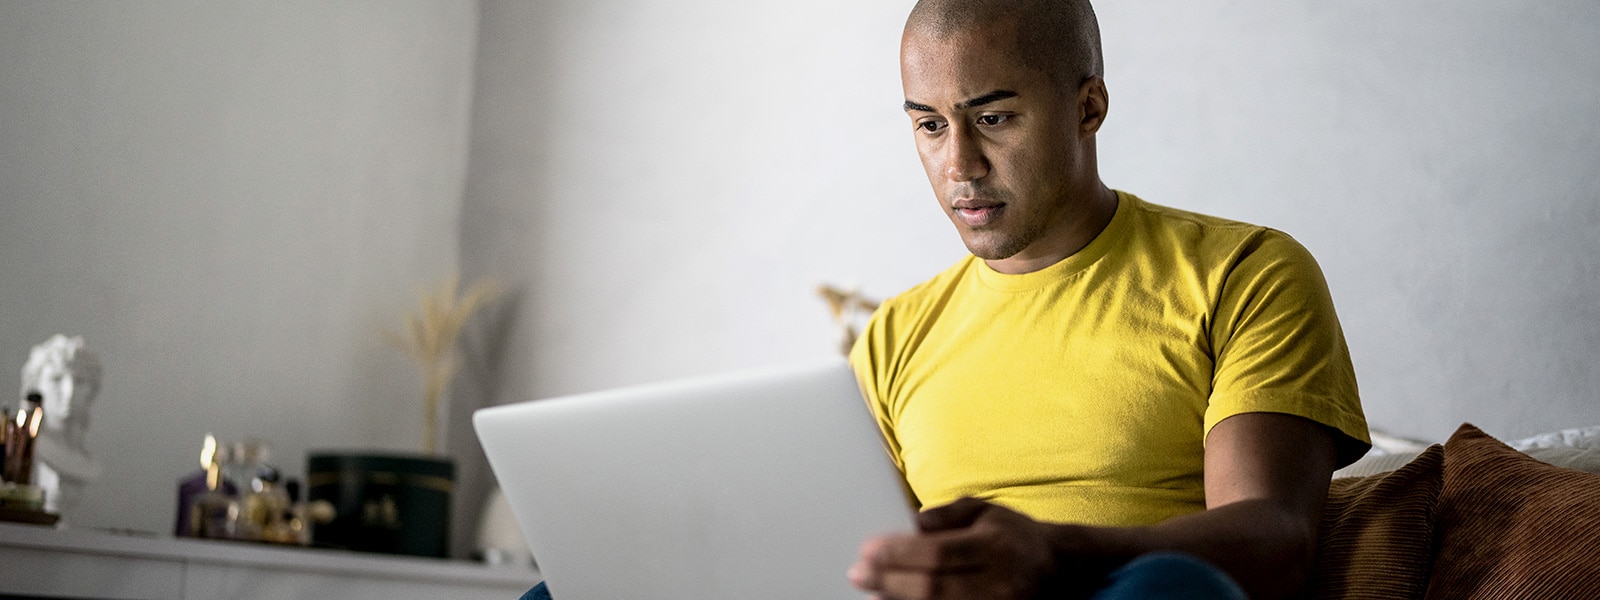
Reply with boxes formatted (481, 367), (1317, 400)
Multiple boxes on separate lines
(850, 0), (1368, 600)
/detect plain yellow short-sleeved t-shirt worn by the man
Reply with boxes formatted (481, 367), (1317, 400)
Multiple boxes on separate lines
(851, 192), (1370, 525)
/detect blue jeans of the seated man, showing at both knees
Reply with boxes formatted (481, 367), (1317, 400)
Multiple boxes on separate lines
(522, 552), (1248, 600)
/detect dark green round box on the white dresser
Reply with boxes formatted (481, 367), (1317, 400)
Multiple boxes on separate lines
(306, 451), (456, 557)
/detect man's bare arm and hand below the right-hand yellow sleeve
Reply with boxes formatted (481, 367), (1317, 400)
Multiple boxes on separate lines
(850, 413), (1339, 600)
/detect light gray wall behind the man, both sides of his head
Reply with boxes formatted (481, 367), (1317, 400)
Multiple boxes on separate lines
(462, 0), (1600, 448)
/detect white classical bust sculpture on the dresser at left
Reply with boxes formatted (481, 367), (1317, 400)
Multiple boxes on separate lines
(22, 334), (101, 515)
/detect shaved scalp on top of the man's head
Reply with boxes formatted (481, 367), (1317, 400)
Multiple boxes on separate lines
(906, 0), (1106, 93)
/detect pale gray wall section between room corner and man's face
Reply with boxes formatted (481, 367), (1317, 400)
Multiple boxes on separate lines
(462, 0), (963, 412)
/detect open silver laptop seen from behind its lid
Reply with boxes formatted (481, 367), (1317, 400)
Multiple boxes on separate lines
(472, 362), (914, 600)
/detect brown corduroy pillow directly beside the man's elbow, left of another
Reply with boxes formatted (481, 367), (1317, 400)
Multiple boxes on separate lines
(1301, 445), (1443, 600)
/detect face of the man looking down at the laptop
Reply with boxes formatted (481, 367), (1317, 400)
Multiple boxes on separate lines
(901, 24), (1083, 264)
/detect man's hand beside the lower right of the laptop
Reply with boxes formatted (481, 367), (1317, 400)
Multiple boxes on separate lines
(850, 498), (1061, 600)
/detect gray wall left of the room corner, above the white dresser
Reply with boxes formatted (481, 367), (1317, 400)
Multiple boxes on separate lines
(0, 0), (477, 550)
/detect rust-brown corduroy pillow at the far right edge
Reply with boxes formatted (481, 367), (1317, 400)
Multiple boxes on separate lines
(1427, 424), (1600, 600)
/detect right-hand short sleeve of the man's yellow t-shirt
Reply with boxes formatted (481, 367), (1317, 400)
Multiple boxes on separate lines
(1205, 230), (1371, 467)
